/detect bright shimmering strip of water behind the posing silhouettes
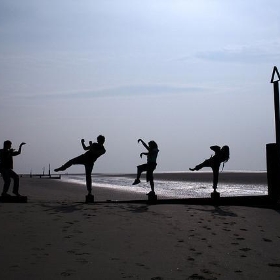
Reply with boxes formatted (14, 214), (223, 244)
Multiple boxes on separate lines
(61, 172), (267, 198)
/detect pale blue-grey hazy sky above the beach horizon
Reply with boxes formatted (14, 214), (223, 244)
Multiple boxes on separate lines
(0, 0), (280, 173)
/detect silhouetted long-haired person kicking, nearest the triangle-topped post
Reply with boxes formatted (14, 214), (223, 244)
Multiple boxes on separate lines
(189, 146), (229, 192)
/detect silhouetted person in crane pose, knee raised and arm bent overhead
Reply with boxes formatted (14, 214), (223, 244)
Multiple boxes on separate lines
(132, 139), (159, 194)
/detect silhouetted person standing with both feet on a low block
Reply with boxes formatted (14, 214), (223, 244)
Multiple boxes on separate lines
(0, 140), (25, 196)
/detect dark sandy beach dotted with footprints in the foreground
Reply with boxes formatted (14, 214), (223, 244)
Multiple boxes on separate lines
(0, 178), (280, 280)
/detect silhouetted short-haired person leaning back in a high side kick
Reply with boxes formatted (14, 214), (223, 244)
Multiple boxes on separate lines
(54, 135), (106, 194)
